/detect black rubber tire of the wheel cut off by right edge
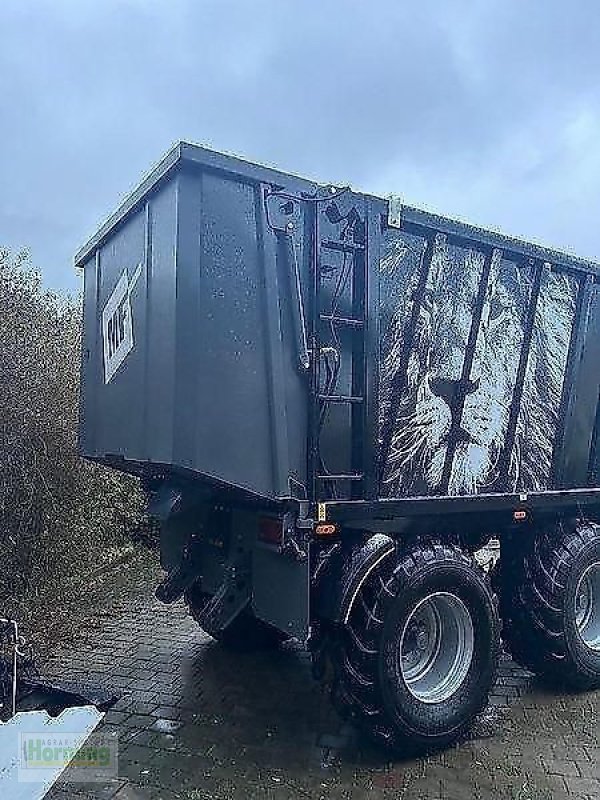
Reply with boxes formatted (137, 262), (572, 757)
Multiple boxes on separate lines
(500, 522), (600, 690)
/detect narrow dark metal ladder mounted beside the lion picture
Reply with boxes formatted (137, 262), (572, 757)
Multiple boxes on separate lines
(309, 196), (368, 502)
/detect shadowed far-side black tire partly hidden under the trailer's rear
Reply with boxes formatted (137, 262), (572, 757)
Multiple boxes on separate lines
(185, 586), (289, 652)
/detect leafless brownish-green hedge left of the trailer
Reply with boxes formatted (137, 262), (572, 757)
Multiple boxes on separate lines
(0, 249), (144, 616)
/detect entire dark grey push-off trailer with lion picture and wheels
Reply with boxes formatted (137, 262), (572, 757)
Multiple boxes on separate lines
(76, 143), (600, 752)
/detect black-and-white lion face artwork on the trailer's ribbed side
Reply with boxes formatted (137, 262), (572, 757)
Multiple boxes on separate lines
(379, 231), (578, 497)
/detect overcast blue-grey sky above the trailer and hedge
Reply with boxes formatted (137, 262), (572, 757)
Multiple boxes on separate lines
(0, 0), (600, 290)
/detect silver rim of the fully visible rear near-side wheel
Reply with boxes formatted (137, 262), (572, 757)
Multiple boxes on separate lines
(398, 592), (474, 703)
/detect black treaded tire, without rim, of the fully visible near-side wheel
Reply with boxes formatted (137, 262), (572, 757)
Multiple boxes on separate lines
(332, 542), (500, 755)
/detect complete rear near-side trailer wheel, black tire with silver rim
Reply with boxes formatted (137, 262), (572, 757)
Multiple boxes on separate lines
(333, 542), (500, 754)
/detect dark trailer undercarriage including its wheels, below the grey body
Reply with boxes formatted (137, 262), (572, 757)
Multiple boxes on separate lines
(150, 482), (600, 753)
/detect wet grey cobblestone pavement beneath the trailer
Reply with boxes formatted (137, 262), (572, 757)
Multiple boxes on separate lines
(46, 590), (600, 800)
